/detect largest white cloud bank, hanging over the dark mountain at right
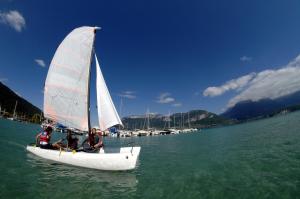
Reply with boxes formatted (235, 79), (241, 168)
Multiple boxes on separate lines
(203, 55), (300, 107)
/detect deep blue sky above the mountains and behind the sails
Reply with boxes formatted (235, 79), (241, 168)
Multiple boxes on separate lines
(0, 0), (300, 124)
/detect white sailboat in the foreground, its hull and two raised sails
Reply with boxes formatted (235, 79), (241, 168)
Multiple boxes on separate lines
(27, 26), (141, 170)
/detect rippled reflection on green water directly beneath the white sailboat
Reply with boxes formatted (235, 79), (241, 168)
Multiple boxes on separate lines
(27, 153), (138, 196)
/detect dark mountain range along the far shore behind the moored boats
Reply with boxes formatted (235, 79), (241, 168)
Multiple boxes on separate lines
(0, 79), (300, 126)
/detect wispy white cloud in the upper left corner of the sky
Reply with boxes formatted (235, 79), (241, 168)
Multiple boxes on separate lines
(0, 10), (26, 32)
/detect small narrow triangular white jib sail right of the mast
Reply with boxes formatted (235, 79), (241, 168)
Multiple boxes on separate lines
(95, 54), (123, 131)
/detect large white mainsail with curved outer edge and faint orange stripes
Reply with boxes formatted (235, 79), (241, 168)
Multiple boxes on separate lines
(44, 27), (96, 131)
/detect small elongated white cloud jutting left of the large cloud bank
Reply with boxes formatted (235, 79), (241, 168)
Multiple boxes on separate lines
(203, 73), (255, 97)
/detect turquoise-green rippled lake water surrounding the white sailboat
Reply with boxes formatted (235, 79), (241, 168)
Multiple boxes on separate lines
(0, 112), (300, 199)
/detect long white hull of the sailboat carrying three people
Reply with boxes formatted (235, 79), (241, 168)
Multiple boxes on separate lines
(26, 146), (141, 171)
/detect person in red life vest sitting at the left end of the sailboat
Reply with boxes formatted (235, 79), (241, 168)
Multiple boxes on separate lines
(36, 126), (59, 149)
